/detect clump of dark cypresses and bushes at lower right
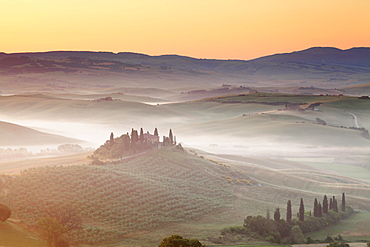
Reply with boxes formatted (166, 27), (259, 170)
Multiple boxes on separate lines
(221, 193), (354, 243)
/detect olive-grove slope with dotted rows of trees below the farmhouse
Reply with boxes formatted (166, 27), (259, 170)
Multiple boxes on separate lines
(2, 147), (255, 243)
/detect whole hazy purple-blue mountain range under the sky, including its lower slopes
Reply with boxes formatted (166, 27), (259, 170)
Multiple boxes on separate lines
(0, 47), (370, 93)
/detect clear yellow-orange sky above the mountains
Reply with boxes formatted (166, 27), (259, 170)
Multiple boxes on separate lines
(0, 0), (370, 60)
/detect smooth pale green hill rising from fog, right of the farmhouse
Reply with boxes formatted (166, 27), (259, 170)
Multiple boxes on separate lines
(178, 114), (370, 147)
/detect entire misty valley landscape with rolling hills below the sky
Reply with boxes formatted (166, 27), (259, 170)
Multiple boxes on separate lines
(0, 47), (370, 247)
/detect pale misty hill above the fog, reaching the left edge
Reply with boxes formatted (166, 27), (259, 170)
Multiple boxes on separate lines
(0, 95), (185, 123)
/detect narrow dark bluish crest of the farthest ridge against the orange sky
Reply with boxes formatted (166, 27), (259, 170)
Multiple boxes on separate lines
(0, 47), (370, 69)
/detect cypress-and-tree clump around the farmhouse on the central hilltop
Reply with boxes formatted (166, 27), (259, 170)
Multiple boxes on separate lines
(91, 128), (176, 160)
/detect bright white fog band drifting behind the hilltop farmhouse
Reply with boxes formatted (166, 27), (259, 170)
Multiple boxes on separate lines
(2, 118), (368, 158)
